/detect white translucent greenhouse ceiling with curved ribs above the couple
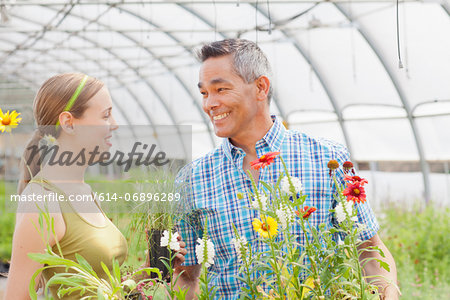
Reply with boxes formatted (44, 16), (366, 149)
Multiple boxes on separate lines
(0, 0), (450, 199)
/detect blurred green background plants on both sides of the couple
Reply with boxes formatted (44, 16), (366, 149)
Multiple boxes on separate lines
(0, 170), (450, 300)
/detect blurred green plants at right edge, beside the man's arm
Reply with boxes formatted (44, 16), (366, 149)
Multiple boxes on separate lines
(379, 204), (450, 300)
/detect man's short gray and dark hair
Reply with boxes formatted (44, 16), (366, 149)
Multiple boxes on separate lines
(197, 39), (273, 103)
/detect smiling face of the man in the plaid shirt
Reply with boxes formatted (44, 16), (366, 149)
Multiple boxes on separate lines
(198, 55), (258, 138)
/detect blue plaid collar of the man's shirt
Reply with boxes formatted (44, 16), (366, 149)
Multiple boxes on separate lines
(222, 115), (286, 161)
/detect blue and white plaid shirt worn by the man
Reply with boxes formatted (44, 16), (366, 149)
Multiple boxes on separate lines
(179, 116), (379, 299)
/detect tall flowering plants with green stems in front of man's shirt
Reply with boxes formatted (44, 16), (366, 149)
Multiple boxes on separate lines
(235, 162), (389, 300)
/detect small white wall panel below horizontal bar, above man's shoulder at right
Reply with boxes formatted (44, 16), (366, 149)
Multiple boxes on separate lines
(345, 119), (419, 161)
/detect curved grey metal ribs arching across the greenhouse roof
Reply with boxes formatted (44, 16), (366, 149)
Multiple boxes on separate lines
(1, 2), (450, 202)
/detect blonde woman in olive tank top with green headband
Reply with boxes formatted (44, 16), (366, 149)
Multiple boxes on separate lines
(5, 73), (186, 299)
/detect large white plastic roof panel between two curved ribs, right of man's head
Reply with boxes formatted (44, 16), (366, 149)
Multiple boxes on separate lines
(298, 28), (400, 106)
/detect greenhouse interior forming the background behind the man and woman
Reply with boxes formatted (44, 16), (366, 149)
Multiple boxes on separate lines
(0, 0), (450, 300)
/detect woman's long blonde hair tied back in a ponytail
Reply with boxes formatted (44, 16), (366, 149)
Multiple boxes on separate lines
(17, 73), (104, 194)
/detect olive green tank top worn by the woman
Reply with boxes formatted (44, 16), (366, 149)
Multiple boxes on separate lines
(30, 178), (128, 300)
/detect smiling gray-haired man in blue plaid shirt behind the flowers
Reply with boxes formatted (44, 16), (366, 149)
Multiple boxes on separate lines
(176, 39), (397, 299)
